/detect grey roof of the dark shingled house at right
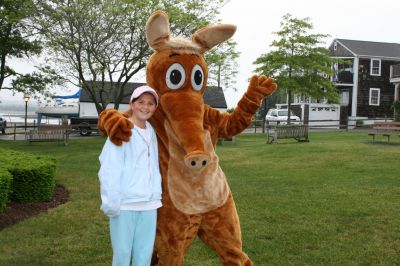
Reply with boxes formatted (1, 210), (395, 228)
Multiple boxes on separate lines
(329, 39), (400, 59)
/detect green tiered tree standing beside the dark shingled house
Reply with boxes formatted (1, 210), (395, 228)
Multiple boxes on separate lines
(254, 14), (338, 123)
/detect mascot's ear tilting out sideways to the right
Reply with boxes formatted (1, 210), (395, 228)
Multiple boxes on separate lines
(192, 24), (236, 53)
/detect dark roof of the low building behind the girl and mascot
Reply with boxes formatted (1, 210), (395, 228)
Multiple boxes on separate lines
(79, 82), (227, 109)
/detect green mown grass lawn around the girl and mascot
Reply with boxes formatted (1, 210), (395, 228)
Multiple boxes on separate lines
(0, 132), (400, 266)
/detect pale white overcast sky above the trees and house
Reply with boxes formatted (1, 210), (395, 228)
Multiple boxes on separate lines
(0, 0), (400, 108)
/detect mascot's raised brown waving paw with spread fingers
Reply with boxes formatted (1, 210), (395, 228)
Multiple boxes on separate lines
(246, 75), (277, 103)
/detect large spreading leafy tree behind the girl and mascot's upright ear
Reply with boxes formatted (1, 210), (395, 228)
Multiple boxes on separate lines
(36, 0), (238, 112)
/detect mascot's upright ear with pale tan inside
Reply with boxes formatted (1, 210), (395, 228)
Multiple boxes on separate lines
(146, 11), (170, 50)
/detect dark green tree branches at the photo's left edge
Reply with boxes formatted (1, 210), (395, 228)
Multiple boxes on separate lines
(0, 0), (59, 96)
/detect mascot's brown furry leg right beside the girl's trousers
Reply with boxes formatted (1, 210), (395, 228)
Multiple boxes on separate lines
(156, 195), (201, 266)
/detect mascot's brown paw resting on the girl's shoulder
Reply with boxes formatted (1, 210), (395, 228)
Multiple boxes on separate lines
(98, 109), (133, 146)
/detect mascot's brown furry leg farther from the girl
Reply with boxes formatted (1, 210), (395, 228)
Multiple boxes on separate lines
(198, 194), (253, 266)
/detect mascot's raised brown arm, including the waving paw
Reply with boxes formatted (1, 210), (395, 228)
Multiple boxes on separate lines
(205, 76), (276, 137)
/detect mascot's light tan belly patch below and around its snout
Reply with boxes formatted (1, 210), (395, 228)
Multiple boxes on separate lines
(165, 121), (230, 214)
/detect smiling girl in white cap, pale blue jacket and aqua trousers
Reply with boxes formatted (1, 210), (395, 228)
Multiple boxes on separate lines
(99, 86), (161, 266)
